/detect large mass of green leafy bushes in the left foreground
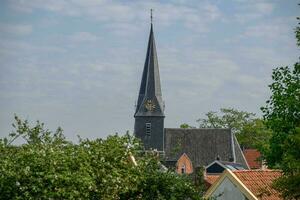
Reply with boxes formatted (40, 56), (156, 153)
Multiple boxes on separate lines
(0, 117), (200, 199)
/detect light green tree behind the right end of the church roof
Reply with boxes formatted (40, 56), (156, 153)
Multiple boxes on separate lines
(197, 108), (271, 149)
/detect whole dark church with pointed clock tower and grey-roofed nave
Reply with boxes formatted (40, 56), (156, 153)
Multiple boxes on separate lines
(134, 16), (249, 174)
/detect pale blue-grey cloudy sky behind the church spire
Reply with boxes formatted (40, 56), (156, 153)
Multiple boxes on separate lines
(0, 0), (300, 141)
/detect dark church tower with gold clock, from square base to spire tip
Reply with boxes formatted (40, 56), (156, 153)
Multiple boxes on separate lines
(134, 10), (165, 151)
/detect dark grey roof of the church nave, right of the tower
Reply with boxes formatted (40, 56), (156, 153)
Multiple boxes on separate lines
(164, 128), (249, 169)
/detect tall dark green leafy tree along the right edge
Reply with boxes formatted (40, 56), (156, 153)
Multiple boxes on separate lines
(261, 15), (300, 199)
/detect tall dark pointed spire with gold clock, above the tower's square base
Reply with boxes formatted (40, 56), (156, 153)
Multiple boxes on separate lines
(135, 12), (164, 116)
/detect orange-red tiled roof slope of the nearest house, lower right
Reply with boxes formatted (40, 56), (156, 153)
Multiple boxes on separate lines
(233, 170), (282, 200)
